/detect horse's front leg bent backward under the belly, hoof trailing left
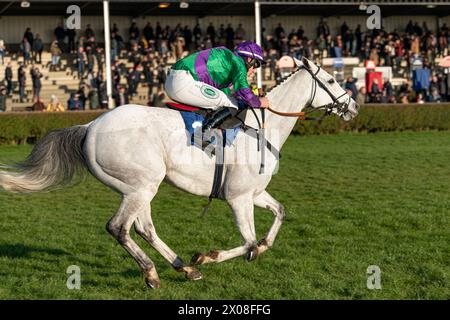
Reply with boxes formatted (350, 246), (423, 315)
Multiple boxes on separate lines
(191, 195), (256, 264)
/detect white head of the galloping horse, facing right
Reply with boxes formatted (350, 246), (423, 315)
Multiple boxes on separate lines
(295, 58), (359, 121)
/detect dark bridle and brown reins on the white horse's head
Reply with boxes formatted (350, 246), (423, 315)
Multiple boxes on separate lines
(267, 62), (351, 121)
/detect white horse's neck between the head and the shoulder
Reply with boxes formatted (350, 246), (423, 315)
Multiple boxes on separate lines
(266, 70), (312, 149)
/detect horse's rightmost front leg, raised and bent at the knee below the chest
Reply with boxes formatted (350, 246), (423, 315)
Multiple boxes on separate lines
(252, 191), (286, 259)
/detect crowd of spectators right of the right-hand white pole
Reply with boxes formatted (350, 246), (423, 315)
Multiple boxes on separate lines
(264, 19), (450, 103)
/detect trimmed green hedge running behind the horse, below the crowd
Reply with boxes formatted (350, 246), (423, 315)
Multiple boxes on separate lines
(0, 104), (450, 144)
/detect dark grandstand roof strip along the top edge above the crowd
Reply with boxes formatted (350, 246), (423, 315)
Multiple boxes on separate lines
(0, 0), (450, 17)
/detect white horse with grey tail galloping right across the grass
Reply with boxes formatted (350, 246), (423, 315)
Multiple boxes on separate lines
(0, 59), (358, 288)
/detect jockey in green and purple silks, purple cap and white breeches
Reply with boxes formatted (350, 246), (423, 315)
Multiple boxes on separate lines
(165, 41), (269, 132)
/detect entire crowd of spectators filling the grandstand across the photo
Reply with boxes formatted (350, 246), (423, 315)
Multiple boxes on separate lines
(0, 19), (450, 111)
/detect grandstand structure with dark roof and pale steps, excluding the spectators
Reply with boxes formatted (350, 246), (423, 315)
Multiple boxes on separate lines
(0, 0), (450, 111)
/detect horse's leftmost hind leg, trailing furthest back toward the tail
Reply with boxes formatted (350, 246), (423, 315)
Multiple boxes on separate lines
(106, 192), (160, 288)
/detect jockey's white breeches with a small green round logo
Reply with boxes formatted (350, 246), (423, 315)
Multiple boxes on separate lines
(166, 70), (238, 110)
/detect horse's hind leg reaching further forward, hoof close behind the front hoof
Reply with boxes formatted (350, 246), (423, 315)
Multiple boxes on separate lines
(134, 205), (202, 280)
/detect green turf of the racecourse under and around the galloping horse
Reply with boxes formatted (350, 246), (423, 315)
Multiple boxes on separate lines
(0, 132), (450, 299)
